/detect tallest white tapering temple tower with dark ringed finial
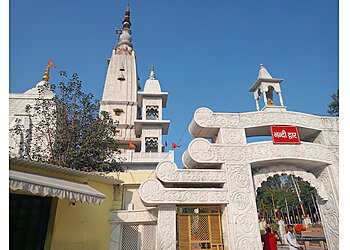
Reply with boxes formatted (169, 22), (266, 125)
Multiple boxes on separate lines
(100, 6), (141, 150)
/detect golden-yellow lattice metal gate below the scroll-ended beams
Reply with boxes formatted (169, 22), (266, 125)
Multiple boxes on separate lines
(177, 206), (223, 250)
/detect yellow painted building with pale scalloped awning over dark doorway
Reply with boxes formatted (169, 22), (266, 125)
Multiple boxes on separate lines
(10, 159), (121, 250)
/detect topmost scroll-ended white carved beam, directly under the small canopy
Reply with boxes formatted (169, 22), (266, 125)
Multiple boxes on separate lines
(189, 108), (339, 137)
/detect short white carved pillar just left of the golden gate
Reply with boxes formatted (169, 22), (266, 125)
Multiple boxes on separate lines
(156, 205), (176, 250)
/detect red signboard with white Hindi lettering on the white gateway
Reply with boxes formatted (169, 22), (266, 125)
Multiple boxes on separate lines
(271, 126), (300, 144)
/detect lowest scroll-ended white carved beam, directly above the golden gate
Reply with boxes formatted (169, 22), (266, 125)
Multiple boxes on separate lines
(139, 179), (228, 205)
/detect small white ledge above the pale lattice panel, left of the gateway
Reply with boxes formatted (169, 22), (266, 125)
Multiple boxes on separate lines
(109, 209), (157, 223)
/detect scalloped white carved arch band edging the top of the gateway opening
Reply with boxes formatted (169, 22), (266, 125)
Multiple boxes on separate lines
(253, 164), (328, 201)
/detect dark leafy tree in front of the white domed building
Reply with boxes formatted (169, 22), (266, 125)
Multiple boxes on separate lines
(10, 71), (121, 172)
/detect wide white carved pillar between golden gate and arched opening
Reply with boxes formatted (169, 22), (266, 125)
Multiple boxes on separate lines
(223, 163), (261, 249)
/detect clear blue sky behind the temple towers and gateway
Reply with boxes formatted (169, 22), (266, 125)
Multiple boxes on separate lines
(10, 0), (339, 167)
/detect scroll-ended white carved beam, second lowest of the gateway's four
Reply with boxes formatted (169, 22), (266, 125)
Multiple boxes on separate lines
(156, 161), (226, 183)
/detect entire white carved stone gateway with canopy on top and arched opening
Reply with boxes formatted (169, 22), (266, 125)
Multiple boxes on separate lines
(139, 66), (339, 250)
